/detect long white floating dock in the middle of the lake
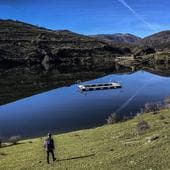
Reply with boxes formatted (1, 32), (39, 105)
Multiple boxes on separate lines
(78, 82), (122, 91)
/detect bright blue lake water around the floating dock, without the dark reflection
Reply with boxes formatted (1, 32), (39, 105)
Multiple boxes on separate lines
(0, 70), (170, 138)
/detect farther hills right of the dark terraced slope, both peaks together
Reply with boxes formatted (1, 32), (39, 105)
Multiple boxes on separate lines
(92, 30), (170, 56)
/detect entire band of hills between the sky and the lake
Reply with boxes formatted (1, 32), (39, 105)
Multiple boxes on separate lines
(0, 20), (170, 66)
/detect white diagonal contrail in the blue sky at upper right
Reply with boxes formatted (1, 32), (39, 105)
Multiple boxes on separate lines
(118, 0), (157, 31)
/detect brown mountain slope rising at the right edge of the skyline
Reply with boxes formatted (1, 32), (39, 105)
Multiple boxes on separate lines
(137, 30), (170, 51)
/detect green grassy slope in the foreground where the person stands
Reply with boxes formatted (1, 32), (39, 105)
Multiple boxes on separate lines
(0, 110), (170, 170)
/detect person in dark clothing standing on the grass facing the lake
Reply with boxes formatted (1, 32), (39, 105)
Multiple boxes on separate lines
(44, 133), (56, 164)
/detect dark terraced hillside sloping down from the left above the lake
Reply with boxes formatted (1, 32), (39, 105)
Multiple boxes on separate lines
(0, 20), (131, 64)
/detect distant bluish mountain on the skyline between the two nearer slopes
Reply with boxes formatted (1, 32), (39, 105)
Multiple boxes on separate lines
(91, 33), (141, 43)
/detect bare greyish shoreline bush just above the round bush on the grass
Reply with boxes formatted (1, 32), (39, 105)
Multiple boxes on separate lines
(144, 102), (162, 114)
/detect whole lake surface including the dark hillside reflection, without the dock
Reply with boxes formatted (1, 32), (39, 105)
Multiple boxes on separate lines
(0, 63), (170, 137)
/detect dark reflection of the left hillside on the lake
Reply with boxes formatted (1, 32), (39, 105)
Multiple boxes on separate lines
(0, 65), (131, 105)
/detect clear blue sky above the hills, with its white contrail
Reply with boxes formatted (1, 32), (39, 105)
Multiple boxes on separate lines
(0, 0), (170, 37)
